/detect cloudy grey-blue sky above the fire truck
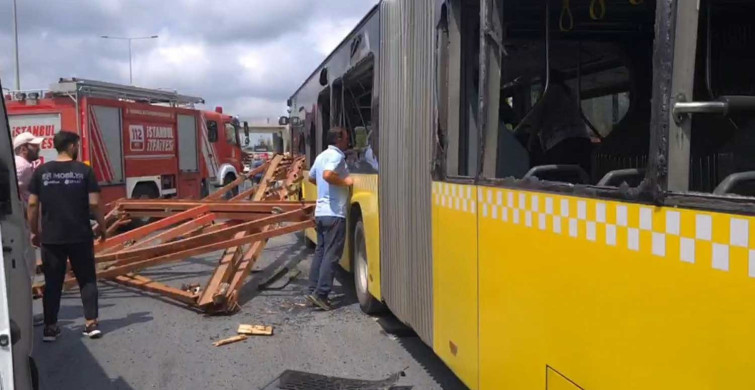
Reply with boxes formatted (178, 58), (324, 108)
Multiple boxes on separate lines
(0, 0), (377, 122)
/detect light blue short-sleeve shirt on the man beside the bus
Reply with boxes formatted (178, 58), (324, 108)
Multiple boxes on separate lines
(309, 145), (349, 218)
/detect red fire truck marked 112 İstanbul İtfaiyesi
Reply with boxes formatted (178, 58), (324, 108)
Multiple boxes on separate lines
(5, 78), (248, 207)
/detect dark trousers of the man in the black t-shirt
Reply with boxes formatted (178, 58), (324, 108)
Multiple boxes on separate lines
(42, 241), (98, 325)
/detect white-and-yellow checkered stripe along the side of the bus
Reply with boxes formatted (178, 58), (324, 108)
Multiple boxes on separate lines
(433, 183), (755, 278)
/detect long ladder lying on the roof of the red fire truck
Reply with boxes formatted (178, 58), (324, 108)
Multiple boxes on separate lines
(50, 77), (204, 107)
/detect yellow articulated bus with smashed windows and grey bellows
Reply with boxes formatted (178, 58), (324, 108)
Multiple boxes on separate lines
(289, 0), (755, 390)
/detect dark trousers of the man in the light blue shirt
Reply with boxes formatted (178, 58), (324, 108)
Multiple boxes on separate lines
(309, 217), (346, 298)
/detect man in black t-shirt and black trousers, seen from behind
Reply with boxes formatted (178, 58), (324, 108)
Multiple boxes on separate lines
(27, 131), (105, 342)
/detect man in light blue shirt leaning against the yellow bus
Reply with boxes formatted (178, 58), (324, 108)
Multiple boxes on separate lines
(307, 127), (354, 310)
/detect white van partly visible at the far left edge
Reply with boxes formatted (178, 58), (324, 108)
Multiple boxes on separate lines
(0, 80), (38, 390)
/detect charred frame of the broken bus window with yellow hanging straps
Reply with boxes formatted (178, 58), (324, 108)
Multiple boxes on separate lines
(475, 0), (676, 205)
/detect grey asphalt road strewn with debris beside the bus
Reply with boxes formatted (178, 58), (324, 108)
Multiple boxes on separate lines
(34, 235), (465, 390)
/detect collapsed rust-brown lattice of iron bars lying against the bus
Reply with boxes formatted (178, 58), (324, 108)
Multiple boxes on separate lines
(33, 155), (314, 313)
